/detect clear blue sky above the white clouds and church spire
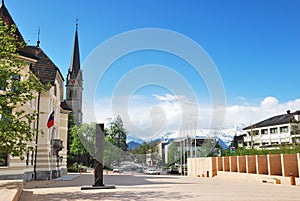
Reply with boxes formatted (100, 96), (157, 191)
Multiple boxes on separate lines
(5, 0), (300, 137)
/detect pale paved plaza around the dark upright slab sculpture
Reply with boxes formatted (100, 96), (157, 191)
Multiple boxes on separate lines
(21, 173), (300, 201)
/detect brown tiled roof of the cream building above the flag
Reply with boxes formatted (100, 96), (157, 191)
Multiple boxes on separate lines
(22, 46), (64, 85)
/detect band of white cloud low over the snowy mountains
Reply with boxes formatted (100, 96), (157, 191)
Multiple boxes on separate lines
(84, 94), (300, 139)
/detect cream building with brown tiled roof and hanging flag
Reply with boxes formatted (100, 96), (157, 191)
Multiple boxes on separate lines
(0, 1), (70, 180)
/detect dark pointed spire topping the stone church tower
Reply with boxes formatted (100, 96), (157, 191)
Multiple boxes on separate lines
(70, 19), (80, 77)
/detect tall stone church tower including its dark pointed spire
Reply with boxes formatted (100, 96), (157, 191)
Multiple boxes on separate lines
(66, 20), (83, 125)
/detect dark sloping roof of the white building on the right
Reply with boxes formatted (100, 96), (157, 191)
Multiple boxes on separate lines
(243, 110), (300, 130)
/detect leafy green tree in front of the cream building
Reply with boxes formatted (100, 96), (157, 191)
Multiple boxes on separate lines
(0, 19), (44, 159)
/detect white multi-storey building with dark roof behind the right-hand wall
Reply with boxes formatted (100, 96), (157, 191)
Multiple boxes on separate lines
(243, 110), (300, 148)
